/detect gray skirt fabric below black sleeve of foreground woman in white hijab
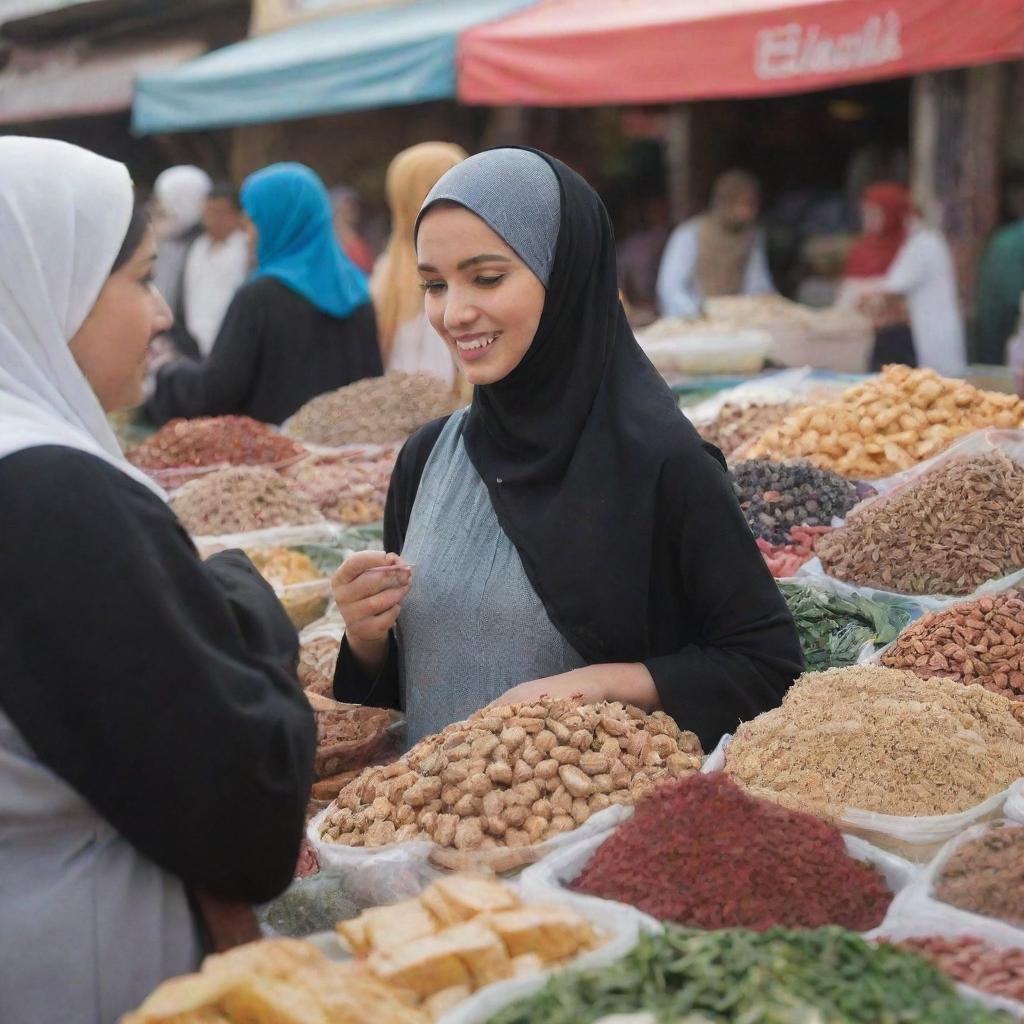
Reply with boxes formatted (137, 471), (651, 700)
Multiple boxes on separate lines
(0, 712), (203, 1024)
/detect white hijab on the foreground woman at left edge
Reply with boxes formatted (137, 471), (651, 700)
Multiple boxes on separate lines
(0, 136), (166, 498)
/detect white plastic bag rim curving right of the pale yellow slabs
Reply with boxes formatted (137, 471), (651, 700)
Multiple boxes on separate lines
(437, 899), (641, 1024)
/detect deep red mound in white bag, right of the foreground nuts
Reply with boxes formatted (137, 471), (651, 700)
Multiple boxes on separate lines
(571, 772), (892, 932)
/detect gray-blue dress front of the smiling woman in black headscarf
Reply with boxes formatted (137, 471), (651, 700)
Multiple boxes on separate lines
(398, 410), (585, 744)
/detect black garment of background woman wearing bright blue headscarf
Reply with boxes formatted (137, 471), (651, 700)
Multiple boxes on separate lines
(145, 278), (384, 424)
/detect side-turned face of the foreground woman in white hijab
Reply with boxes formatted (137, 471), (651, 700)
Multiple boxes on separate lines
(71, 228), (174, 413)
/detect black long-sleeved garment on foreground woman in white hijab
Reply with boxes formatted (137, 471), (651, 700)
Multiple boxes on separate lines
(0, 445), (316, 902)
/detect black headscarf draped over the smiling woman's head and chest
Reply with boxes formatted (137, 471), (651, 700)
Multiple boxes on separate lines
(415, 151), (724, 662)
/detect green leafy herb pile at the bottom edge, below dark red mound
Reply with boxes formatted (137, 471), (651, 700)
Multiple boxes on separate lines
(490, 926), (1012, 1024)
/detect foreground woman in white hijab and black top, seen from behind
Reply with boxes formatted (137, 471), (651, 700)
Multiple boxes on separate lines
(0, 137), (315, 1024)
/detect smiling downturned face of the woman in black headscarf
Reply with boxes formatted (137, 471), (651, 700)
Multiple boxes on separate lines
(416, 206), (545, 386)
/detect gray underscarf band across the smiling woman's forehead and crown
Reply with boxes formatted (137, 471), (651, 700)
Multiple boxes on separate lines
(416, 150), (561, 288)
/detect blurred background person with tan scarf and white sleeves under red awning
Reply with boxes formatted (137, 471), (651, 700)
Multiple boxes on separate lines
(657, 170), (775, 316)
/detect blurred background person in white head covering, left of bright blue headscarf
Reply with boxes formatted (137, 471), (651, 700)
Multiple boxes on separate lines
(153, 164), (213, 318)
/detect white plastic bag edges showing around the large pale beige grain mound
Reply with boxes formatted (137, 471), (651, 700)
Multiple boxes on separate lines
(701, 735), (1013, 864)
